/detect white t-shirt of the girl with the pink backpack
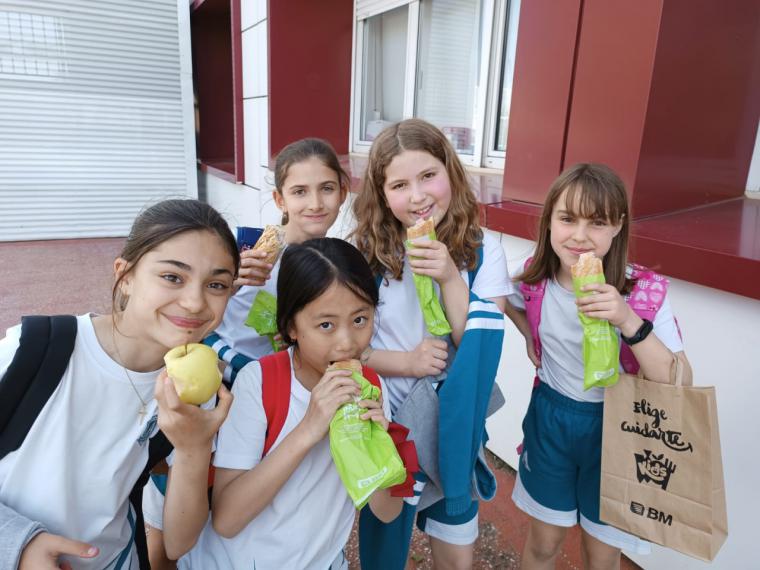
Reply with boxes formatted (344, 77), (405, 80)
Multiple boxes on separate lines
(509, 279), (683, 402)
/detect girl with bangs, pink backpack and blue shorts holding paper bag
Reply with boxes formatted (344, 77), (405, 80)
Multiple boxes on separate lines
(512, 164), (690, 569)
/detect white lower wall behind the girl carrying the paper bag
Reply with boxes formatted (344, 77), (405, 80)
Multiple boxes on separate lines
(487, 234), (760, 570)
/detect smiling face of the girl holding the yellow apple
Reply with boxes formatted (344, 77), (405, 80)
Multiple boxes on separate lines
(115, 231), (235, 352)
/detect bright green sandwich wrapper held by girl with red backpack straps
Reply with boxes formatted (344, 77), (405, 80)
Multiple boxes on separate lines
(330, 360), (406, 509)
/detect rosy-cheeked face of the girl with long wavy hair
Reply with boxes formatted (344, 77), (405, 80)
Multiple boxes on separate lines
(383, 150), (451, 228)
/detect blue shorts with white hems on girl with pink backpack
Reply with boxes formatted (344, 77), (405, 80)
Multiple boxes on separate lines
(512, 382), (649, 554)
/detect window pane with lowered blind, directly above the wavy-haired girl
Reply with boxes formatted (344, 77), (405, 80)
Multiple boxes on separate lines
(415, 0), (483, 154)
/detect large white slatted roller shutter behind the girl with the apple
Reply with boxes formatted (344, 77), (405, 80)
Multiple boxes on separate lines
(0, 0), (197, 241)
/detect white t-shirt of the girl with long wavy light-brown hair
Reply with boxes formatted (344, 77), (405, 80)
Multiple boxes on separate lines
(371, 234), (514, 413)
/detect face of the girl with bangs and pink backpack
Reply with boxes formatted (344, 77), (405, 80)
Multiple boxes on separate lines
(549, 186), (622, 285)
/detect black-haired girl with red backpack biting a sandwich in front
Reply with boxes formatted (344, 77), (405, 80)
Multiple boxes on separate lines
(179, 238), (401, 570)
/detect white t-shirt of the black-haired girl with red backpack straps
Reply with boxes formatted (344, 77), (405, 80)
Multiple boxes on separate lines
(179, 348), (390, 570)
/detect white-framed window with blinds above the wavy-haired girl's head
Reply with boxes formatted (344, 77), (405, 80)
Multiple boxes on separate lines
(352, 0), (520, 168)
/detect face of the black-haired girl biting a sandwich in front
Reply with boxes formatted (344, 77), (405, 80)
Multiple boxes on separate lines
(288, 281), (374, 388)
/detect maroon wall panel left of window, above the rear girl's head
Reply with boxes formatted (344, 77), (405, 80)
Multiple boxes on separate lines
(269, 0), (354, 156)
